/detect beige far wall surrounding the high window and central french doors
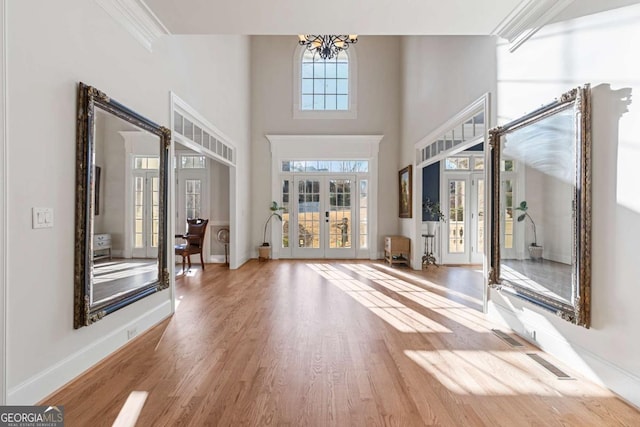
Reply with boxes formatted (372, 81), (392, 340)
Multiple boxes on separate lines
(251, 36), (401, 257)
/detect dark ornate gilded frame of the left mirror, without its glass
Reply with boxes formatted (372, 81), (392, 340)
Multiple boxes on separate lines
(73, 83), (171, 329)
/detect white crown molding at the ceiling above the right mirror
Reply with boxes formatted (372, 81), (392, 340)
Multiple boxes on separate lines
(492, 0), (574, 52)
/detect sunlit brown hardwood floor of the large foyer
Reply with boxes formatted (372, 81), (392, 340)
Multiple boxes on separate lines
(42, 261), (640, 426)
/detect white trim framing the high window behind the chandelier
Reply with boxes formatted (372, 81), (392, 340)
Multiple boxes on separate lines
(293, 45), (358, 119)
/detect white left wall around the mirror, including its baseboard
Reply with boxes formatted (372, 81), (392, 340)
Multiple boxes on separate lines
(5, 0), (249, 404)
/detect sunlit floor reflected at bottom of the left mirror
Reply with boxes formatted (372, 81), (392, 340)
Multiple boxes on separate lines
(93, 258), (158, 302)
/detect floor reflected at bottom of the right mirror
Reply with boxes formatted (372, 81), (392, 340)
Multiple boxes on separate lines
(500, 259), (572, 303)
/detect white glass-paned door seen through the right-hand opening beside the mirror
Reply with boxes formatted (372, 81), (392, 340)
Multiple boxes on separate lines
(441, 173), (485, 264)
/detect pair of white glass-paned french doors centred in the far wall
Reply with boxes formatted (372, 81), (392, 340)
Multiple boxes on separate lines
(289, 175), (358, 258)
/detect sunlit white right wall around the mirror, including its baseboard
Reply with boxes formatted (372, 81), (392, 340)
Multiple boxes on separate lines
(490, 5), (640, 406)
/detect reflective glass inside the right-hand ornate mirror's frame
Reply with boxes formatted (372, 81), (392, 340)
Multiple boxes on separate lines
(500, 107), (576, 303)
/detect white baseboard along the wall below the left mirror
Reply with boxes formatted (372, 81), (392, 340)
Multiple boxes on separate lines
(7, 301), (171, 405)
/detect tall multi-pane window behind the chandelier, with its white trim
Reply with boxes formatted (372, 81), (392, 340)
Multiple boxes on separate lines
(294, 47), (356, 119)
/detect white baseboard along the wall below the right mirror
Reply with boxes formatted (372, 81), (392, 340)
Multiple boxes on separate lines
(488, 300), (640, 409)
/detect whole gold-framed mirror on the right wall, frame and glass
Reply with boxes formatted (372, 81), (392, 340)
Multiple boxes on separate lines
(489, 85), (591, 328)
